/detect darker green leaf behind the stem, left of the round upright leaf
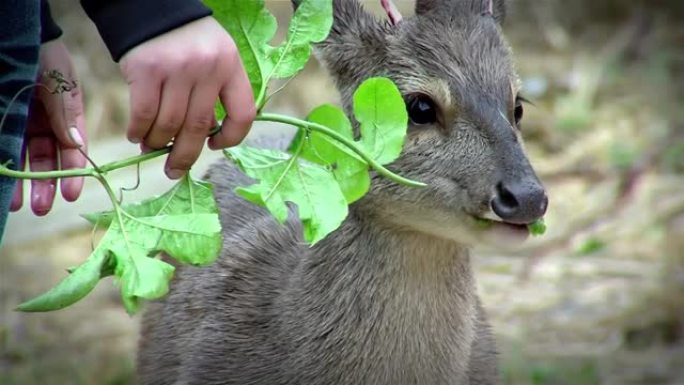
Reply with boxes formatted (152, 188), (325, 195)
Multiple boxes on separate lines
(289, 105), (370, 203)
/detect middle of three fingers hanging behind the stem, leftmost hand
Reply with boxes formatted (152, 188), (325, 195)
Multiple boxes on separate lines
(28, 136), (57, 216)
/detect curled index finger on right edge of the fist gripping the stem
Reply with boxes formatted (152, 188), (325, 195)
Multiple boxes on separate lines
(209, 57), (256, 150)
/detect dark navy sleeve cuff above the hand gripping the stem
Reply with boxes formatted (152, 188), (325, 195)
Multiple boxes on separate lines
(81, 0), (211, 62)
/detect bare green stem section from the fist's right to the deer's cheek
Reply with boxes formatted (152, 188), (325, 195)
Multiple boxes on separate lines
(257, 113), (426, 187)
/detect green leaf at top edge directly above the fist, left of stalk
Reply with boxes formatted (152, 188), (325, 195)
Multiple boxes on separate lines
(204, 0), (278, 97)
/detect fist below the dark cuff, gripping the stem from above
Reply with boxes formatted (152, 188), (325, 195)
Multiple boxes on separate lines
(121, 17), (256, 179)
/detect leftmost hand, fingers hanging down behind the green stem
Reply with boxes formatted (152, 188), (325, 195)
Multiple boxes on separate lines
(10, 39), (86, 216)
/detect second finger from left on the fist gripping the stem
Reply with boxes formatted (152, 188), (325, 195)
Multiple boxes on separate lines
(144, 78), (192, 149)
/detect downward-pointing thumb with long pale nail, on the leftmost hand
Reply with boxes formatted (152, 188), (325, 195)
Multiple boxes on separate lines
(37, 75), (85, 148)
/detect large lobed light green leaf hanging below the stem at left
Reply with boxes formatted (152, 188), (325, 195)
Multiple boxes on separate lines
(19, 175), (222, 313)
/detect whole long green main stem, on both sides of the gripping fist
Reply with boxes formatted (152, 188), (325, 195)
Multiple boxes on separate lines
(0, 113), (425, 187)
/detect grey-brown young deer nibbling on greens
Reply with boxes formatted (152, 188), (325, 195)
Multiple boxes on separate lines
(137, 0), (548, 385)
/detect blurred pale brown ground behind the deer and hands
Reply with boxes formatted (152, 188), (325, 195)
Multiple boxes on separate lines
(0, 0), (684, 385)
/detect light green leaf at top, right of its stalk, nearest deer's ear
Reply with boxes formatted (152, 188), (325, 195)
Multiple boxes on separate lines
(267, 0), (333, 78)
